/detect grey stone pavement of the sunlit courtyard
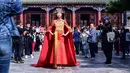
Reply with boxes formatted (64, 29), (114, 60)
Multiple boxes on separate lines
(10, 51), (130, 73)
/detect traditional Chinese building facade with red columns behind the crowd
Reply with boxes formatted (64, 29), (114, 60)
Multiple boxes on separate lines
(15, 0), (122, 27)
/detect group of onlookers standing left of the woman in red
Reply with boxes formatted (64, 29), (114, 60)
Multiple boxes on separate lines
(12, 23), (45, 63)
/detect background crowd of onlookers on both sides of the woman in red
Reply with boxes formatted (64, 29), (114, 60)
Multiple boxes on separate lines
(12, 19), (130, 64)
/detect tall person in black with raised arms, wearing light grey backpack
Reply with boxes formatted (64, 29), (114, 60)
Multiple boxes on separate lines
(101, 18), (113, 64)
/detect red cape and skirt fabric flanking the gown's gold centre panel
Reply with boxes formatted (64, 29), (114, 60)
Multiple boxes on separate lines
(32, 21), (79, 67)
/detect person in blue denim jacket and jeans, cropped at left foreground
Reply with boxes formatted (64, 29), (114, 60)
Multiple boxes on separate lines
(0, 0), (22, 73)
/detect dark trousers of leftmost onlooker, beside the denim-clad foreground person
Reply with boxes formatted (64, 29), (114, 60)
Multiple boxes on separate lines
(13, 38), (23, 61)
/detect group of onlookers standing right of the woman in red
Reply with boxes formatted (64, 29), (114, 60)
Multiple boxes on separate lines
(73, 18), (130, 64)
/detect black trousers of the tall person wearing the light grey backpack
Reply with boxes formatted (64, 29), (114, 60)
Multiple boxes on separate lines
(102, 42), (113, 63)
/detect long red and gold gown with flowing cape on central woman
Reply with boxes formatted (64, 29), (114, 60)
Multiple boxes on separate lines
(33, 20), (79, 67)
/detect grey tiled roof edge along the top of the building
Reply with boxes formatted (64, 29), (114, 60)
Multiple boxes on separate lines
(23, 0), (111, 4)
